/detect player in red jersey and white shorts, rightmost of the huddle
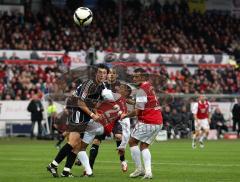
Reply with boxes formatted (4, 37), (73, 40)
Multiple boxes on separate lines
(121, 68), (163, 179)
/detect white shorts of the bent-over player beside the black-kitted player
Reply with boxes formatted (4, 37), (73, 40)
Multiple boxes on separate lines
(82, 120), (104, 144)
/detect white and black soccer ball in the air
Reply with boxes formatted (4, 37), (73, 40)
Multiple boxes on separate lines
(73, 7), (93, 26)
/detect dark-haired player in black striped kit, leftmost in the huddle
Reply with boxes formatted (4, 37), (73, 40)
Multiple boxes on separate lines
(47, 64), (109, 177)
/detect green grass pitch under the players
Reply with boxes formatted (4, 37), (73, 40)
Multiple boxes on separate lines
(0, 138), (240, 182)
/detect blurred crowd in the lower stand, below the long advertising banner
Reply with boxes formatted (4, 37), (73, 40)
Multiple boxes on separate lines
(0, 64), (240, 100)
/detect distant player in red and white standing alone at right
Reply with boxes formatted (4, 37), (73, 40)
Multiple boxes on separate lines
(192, 95), (211, 148)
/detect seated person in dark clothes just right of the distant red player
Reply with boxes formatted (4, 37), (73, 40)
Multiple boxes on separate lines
(210, 108), (228, 138)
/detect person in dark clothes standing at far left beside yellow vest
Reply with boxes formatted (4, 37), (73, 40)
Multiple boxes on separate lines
(27, 95), (44, 139)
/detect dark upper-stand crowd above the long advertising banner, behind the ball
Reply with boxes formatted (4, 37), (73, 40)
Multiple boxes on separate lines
(0, 0), (240, 54)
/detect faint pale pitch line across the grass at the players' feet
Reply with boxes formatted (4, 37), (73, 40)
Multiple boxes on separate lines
(0, 158), (240, 167)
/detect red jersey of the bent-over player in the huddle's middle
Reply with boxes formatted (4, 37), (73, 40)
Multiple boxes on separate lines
(97, 97), (127, 135)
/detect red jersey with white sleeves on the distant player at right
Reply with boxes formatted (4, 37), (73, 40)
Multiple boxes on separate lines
(193, 101), (210, 119)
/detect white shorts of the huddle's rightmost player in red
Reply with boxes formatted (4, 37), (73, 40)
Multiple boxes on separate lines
(131, 122), (162, 144)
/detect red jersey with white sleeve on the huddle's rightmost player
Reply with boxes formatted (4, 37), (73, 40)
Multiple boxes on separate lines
(136, 82), (163, 124)
